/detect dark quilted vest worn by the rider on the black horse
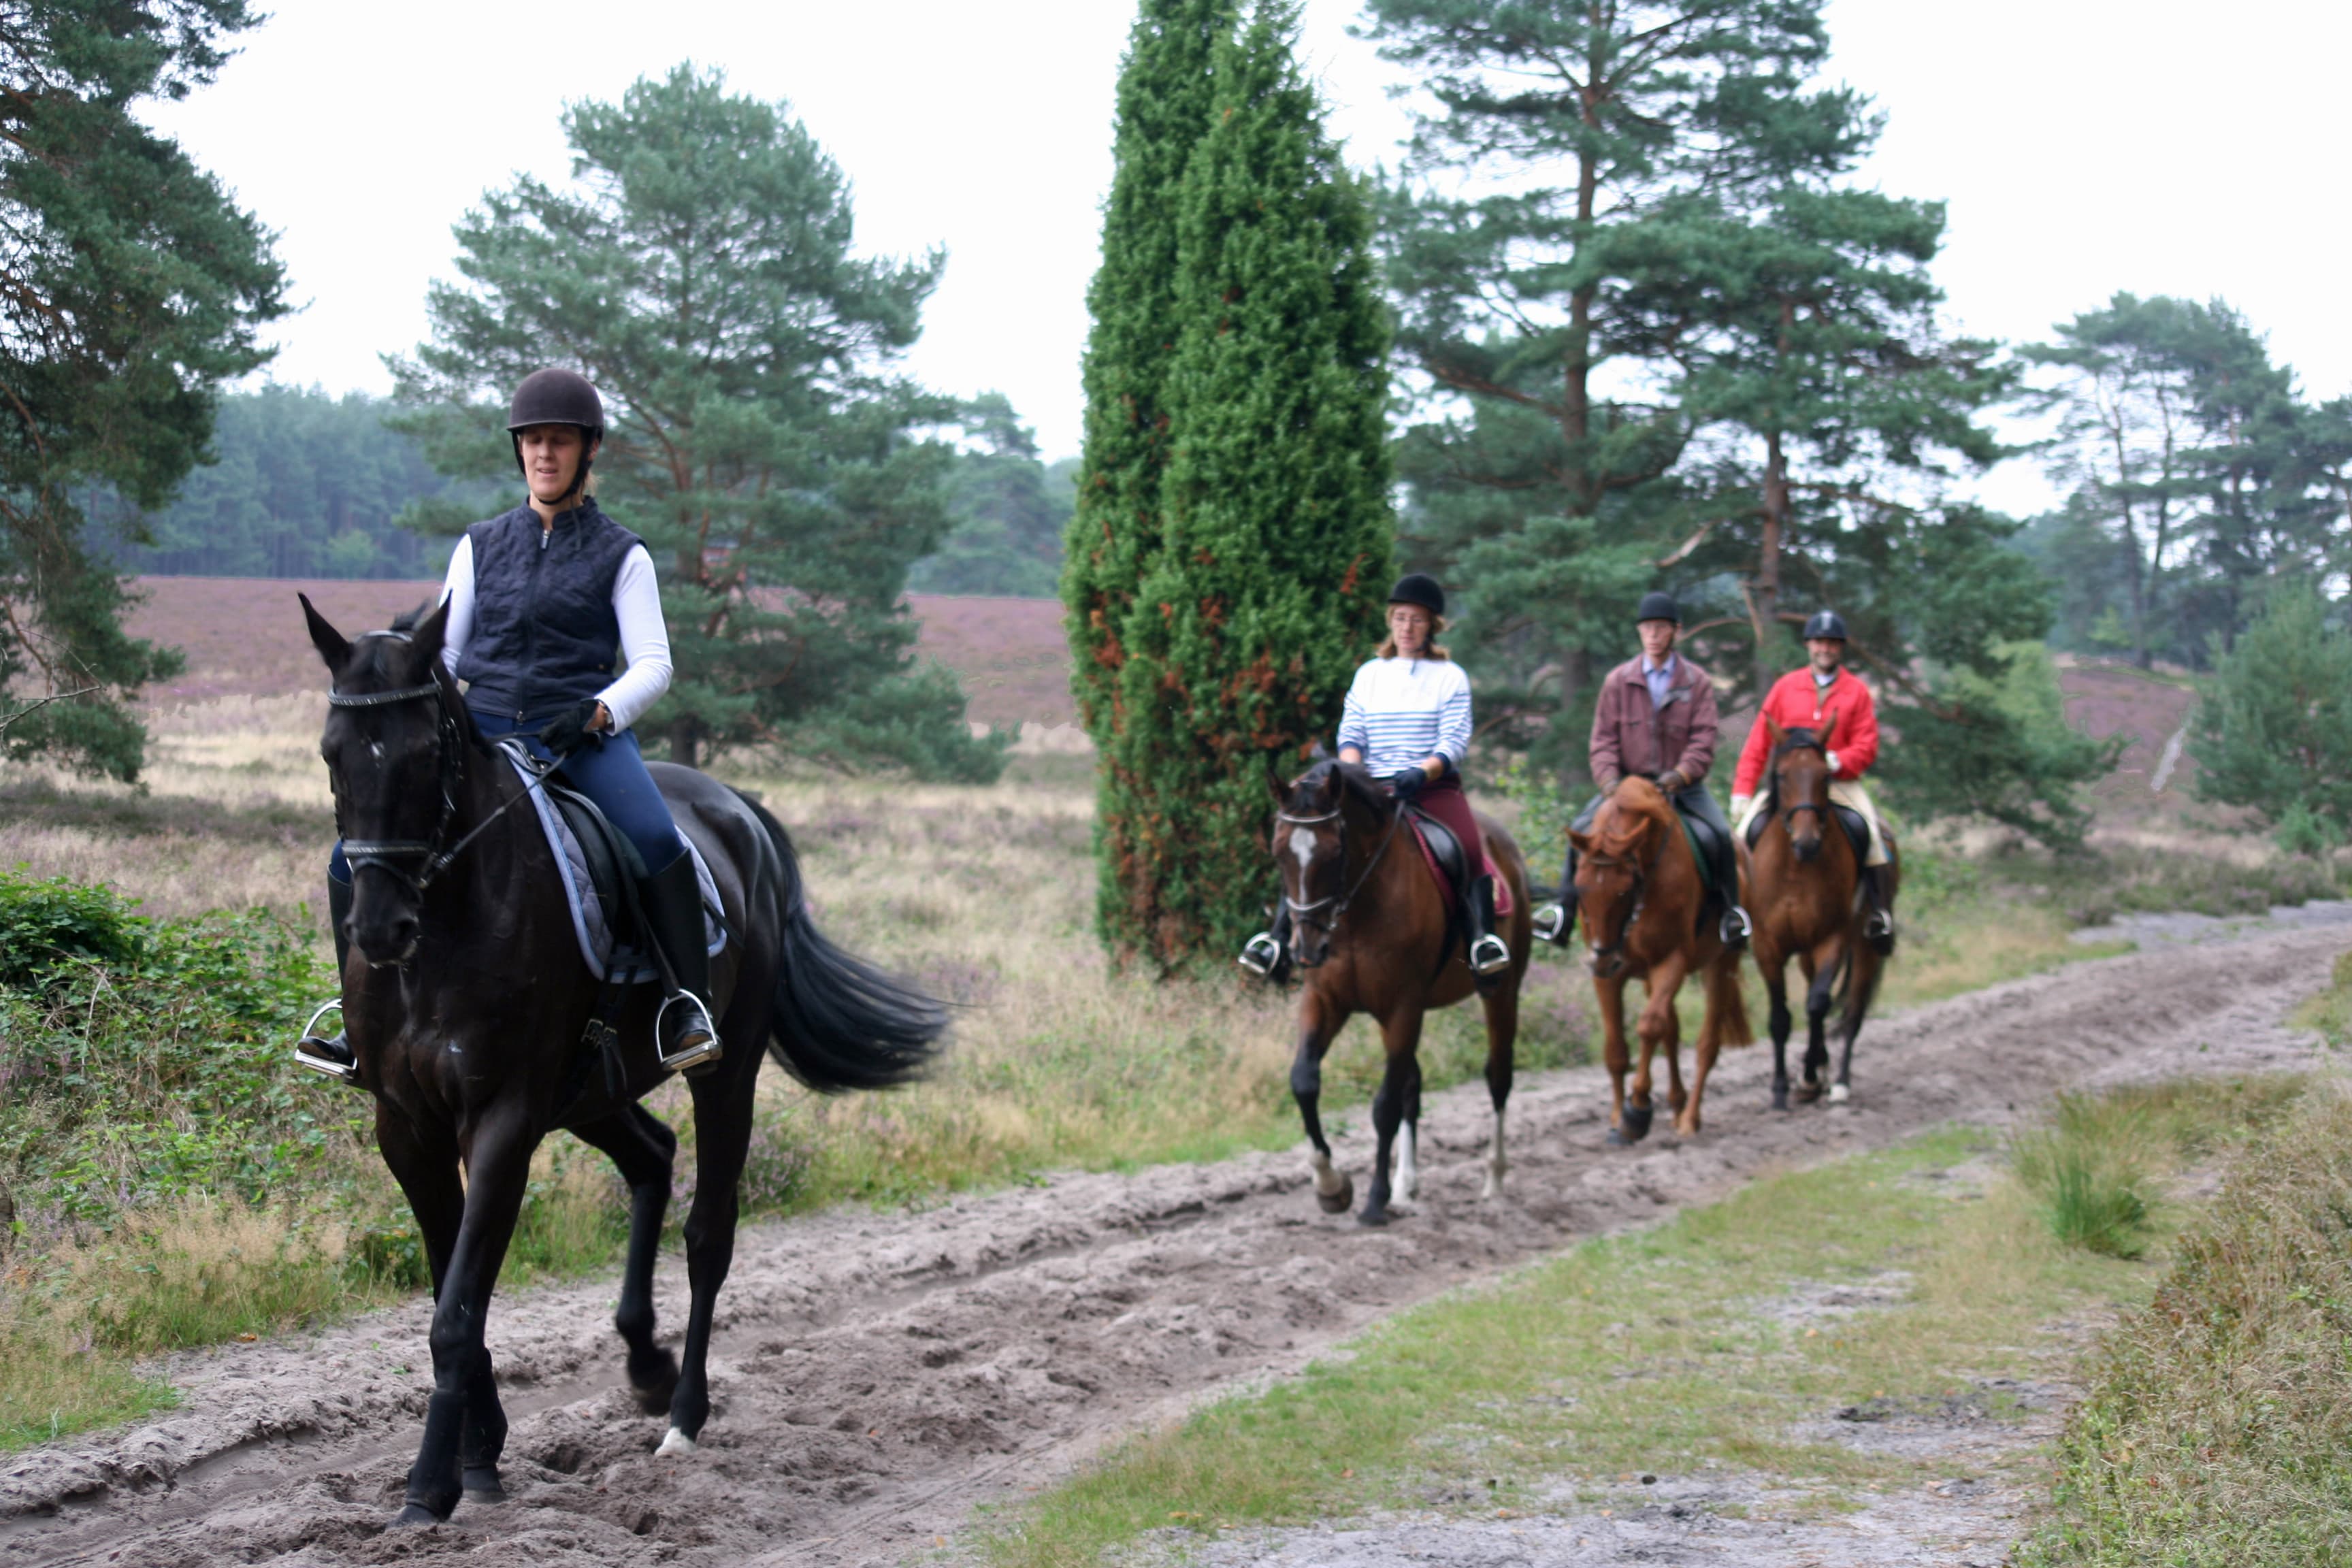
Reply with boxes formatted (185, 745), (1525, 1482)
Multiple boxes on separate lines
(456, 501), (640, 719)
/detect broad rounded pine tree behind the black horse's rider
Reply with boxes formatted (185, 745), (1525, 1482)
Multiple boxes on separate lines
(395, 66), (1002, 778)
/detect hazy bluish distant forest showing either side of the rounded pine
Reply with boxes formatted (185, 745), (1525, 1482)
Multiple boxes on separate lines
(89, 386), (1077, 597)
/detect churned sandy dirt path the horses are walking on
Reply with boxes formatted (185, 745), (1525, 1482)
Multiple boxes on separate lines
(0, 928), (2347, 1568)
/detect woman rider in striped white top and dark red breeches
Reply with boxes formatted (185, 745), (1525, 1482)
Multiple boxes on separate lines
(1239, 571), (1510, 983)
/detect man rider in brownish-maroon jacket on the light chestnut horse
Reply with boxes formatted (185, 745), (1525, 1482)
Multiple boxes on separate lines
(1536, 592), (1748, 947)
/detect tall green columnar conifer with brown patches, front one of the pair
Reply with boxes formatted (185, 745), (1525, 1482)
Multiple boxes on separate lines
(1079, 0), (1390, 966)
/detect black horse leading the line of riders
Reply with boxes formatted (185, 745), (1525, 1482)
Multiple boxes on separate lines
(304, 597), (945, 1526)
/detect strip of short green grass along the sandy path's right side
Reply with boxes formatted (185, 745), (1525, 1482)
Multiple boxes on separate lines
(983, 1083), (2293, 1568)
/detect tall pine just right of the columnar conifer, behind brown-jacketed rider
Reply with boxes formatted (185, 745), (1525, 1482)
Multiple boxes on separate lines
(1369, 0), (1870, 773)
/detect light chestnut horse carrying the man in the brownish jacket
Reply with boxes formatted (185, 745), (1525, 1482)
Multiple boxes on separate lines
(1569, 778), (1754, 1143)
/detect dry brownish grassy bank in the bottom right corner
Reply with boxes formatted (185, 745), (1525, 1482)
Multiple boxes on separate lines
(2021, 1093), (2352, 1568)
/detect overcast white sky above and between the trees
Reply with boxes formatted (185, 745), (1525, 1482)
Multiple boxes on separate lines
(153, 0), (2352, 508)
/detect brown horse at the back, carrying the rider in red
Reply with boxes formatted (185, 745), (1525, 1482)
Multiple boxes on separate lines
(1738, 715), (1898, 1109)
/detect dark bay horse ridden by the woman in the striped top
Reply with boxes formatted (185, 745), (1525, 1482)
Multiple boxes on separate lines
(1273, 762), (1529, 1225)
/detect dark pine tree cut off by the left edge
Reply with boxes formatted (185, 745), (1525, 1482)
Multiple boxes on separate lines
(0, 0), (284, 778)
